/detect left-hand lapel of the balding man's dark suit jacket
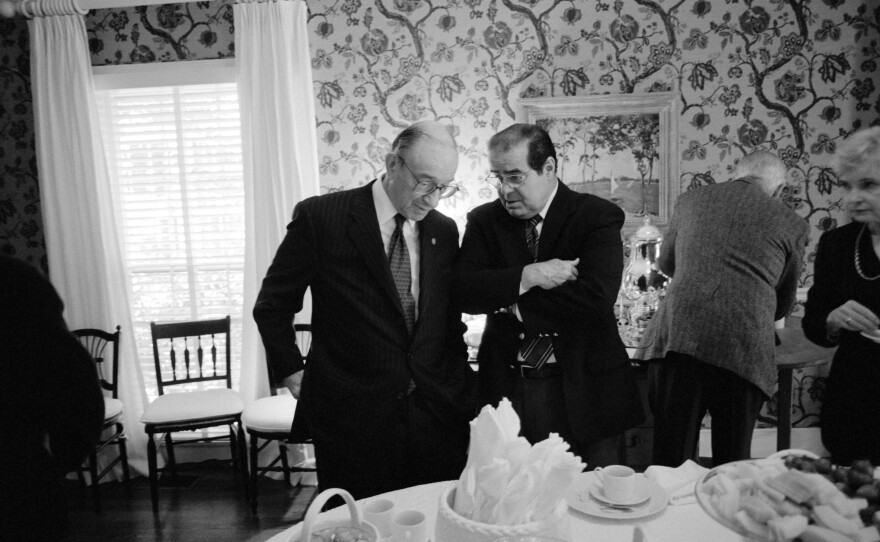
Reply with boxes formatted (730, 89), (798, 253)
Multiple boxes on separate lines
(348, 181), (403, 314)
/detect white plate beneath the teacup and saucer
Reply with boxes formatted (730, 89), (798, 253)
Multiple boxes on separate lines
(565, 472), (669, 519)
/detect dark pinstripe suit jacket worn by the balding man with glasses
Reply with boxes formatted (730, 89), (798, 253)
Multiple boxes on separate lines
(254, 181), (475, 446)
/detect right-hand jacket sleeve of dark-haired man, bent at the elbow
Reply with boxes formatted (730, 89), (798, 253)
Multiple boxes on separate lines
(517, 205), (624, 334)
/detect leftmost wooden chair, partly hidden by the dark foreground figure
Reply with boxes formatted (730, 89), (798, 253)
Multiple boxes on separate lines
(73, 326), (131, 512)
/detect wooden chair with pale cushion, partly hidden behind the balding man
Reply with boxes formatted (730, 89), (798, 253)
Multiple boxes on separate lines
(242, 324), (316, 514)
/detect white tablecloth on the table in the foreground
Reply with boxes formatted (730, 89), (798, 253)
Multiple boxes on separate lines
(269, 482), (743, 542)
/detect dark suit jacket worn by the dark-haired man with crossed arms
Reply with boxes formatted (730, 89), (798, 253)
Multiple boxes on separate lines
(455, 183), (644, 446)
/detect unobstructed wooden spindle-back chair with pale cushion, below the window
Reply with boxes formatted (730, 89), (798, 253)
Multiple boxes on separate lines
(141, 316), (248, 514)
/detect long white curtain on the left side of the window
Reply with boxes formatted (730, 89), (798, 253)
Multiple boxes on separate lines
(23, 0), (147, 474)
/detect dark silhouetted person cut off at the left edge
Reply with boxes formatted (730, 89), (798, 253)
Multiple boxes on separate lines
(0, 256), (104, 541)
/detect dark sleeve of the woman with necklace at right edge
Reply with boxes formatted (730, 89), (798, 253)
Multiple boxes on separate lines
(801, 233), (846, 347)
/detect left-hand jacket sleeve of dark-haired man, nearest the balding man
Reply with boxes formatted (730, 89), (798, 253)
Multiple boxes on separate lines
(453, 212), (523, 314)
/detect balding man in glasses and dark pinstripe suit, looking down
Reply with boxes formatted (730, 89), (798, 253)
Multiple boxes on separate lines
(254, 122), (476, 498)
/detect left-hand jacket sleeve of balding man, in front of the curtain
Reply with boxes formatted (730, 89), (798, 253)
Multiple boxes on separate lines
(253, 202), (317, 382)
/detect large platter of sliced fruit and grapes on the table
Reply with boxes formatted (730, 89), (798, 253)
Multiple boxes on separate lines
(695, 453), (880, 542)
